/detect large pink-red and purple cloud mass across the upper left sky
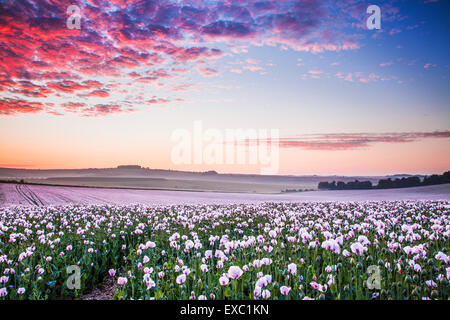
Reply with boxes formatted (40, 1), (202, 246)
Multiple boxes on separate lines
(0, 0), (372, 115)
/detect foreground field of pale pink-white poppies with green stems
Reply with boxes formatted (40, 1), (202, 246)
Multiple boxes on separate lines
(0, 201), (450, 300)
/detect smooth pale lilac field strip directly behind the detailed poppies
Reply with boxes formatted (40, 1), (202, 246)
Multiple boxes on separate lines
(0, 183), (450, 206)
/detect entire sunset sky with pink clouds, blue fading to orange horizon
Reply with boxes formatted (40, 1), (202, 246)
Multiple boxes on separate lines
(0, 0), (450, 175)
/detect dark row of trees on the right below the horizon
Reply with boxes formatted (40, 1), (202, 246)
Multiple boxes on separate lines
(318, 171), (450, 190)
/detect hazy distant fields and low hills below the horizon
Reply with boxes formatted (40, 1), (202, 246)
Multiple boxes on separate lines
(0, 168), (385, 194)
